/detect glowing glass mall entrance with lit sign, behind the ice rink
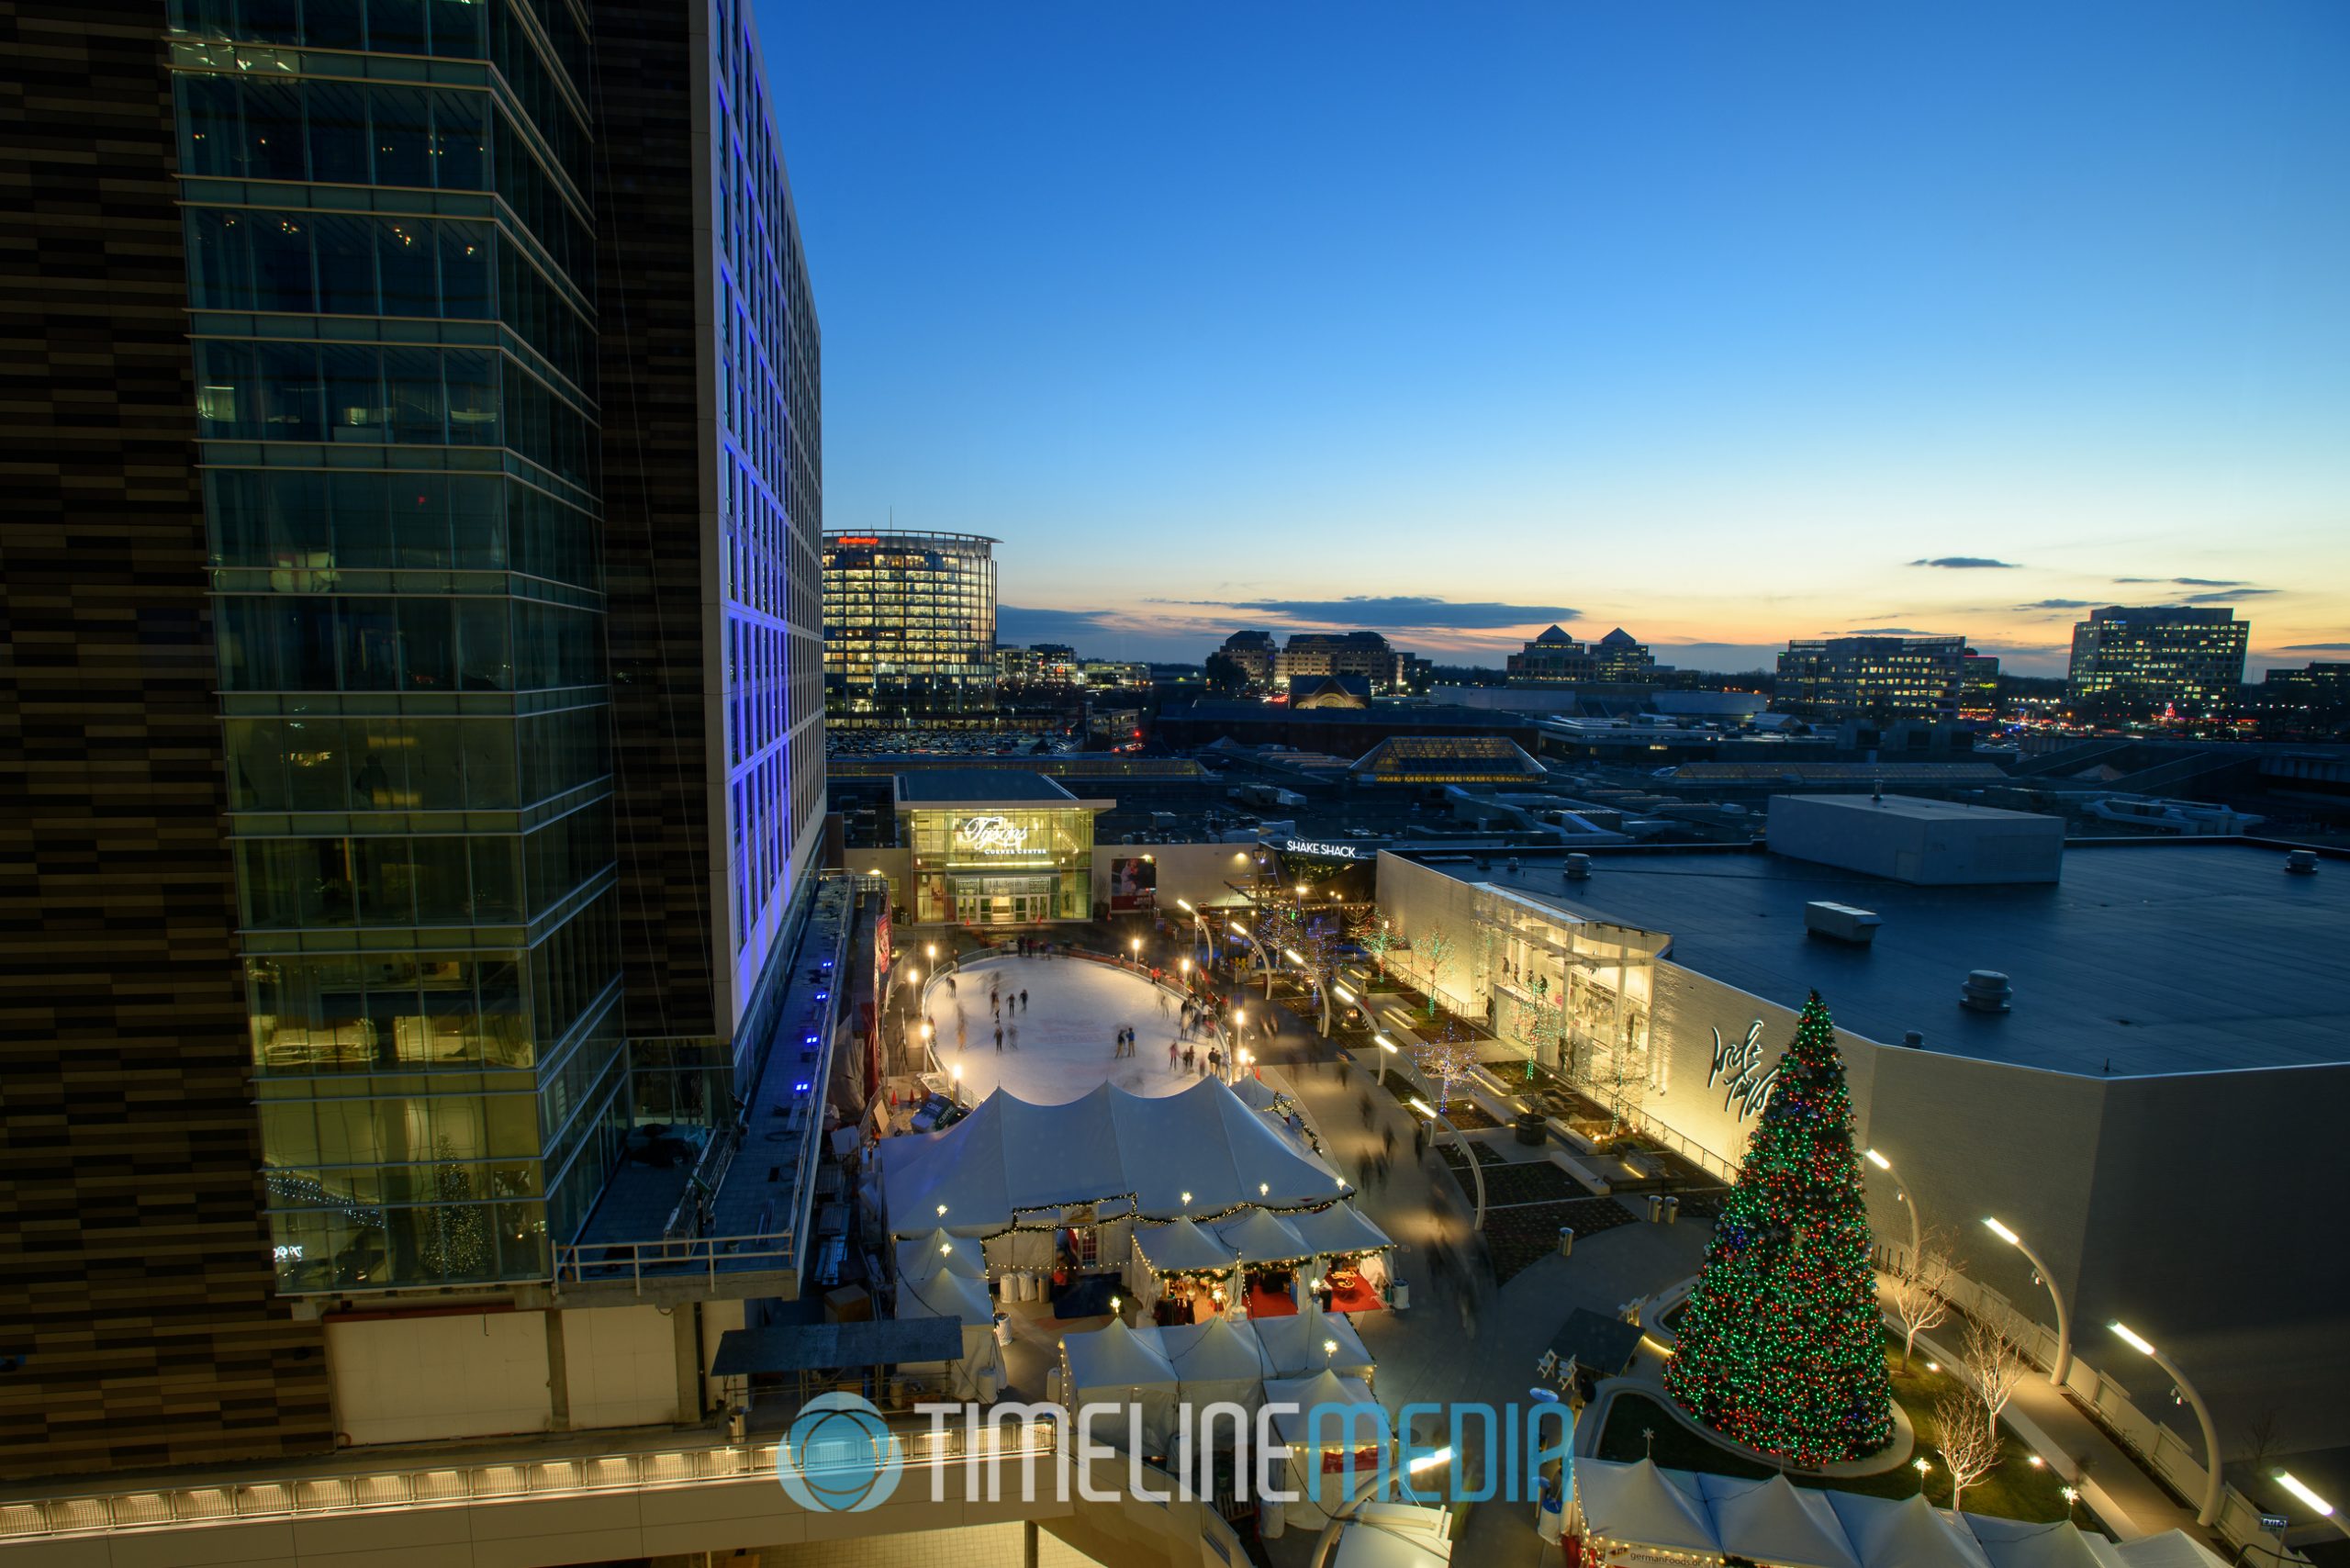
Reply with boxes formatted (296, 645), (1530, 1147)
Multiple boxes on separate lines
(895, 768), (1109, 926)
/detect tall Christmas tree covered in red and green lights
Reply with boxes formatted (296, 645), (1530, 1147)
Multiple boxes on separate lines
(1663, 992), (1894, 1464)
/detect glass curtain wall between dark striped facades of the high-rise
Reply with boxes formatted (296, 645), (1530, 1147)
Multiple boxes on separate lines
(169, 0), (625, 1291)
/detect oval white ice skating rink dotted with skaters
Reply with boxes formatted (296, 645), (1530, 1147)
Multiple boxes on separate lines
(923, 957), (1210, 1105)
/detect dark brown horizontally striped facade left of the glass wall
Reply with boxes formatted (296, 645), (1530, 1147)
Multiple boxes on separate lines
(0, 0), (334, 1476)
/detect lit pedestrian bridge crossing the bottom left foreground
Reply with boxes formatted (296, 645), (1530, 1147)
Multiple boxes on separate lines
(0, 1420), (1248, 1568)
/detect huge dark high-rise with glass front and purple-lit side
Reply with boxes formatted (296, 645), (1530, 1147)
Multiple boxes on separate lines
(0, 0), (822, 1474)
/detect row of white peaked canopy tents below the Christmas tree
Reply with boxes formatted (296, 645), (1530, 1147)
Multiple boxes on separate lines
(1568, 1460), (2171, 1568)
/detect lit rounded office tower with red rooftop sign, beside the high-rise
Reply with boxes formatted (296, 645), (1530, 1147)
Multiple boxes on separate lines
(825, 533), (996, 726)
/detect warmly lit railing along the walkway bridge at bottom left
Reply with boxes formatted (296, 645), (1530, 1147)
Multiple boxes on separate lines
(0, 1420), (1060, 1542)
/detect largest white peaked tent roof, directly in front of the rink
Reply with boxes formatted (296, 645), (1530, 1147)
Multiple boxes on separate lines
(878, 1079), (1351, 1258)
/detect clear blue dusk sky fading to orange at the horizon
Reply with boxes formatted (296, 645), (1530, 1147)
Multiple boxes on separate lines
(759, 0), (2350, 670)
